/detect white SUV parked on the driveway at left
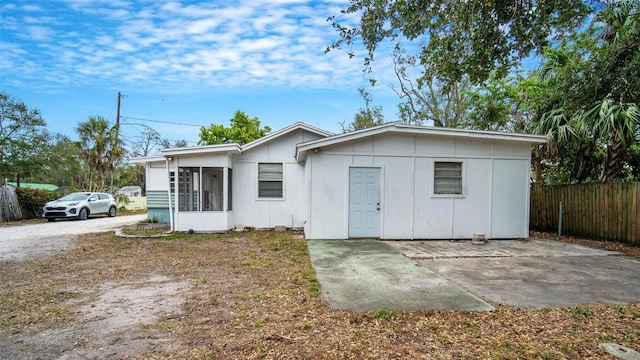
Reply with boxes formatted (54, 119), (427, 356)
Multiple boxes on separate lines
(42, 192), (116, 221)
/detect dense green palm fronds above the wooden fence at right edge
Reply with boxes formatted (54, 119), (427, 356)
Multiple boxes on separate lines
(532, 1), (640, 182)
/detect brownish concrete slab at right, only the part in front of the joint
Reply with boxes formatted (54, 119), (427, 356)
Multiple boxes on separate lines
(416, 256), (640, 308)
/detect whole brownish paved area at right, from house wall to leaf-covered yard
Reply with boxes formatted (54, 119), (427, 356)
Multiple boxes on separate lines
(385, 239), (640, 308)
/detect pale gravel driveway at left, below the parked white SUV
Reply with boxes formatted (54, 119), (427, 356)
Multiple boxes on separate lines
(0, 214), (147, 260)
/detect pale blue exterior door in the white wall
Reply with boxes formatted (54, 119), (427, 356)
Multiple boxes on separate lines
(349, 168), (380, 238)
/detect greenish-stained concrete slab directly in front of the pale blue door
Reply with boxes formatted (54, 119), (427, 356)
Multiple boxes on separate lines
(307, 240), (494, 311)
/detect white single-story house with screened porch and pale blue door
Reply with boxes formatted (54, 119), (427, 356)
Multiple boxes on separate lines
(132, 122), (546, 239)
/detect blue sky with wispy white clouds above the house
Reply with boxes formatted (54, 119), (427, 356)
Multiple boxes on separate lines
(0, 0), (398, 145)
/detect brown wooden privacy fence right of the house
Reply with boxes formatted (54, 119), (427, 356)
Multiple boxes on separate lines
(529, 183), (640, 246)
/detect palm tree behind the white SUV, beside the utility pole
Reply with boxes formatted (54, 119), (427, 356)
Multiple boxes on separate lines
(76, 116), (124, 190)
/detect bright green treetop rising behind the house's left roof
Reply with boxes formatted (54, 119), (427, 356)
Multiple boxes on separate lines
(198, 110), (271, 145)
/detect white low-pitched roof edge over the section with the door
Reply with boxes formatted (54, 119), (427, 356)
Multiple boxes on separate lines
(296, 122), (547, 161)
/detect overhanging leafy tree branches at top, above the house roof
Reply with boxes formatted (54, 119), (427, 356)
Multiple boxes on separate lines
(327, 0), (591, 84)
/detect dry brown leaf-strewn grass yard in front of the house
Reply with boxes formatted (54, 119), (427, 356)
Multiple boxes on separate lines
(0, 232), (640, 359)
